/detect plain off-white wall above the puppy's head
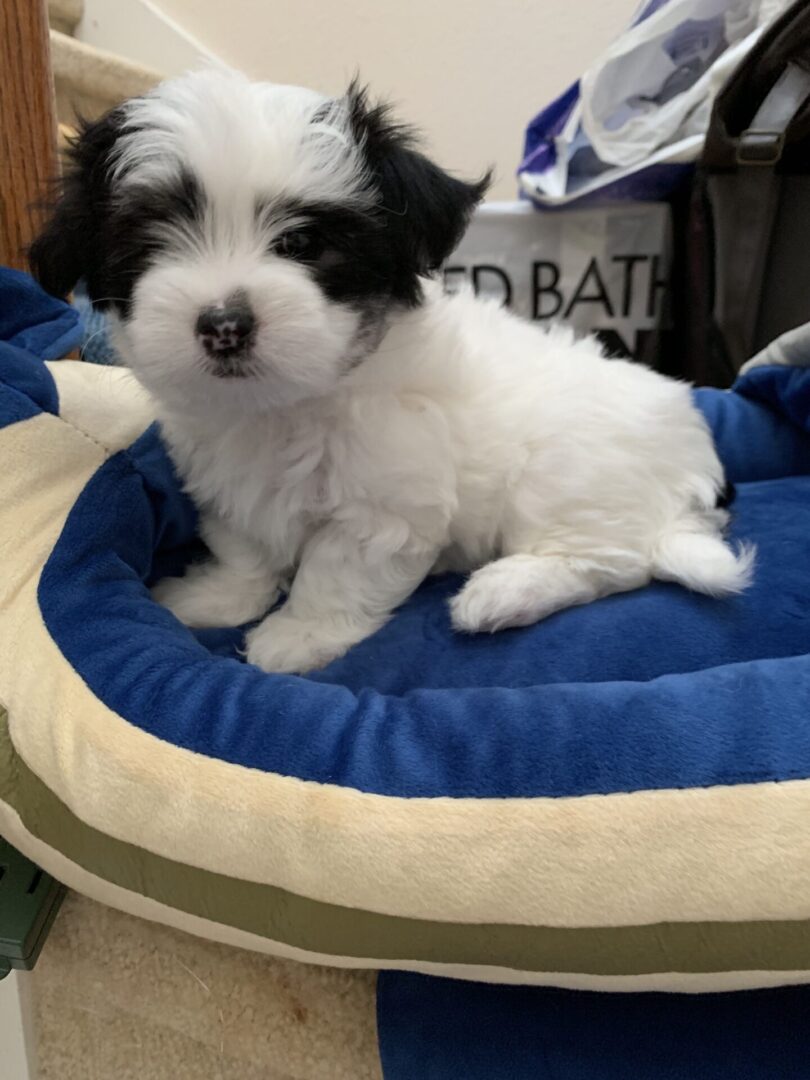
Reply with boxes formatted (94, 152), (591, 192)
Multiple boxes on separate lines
(141, 0), (637, 199)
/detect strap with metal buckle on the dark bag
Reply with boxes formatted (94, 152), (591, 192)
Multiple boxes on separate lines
(708, 60), (810, 370)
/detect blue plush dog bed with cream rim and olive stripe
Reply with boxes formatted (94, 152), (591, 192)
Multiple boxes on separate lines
(0, 265), (810, 989)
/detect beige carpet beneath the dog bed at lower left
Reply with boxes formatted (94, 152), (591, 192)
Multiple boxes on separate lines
(31, 894), (381, 1080)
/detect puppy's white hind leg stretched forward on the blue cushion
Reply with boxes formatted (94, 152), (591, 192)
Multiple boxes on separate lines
(450, 555), (649, 634)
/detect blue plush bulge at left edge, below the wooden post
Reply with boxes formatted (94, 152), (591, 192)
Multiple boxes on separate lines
(0, 267), (83, 360)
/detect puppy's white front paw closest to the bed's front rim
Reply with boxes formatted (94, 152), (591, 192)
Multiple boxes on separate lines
(245, 610), (370, 674)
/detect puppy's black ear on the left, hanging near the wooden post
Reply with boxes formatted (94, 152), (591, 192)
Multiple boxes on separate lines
(28, 107), (123, 297)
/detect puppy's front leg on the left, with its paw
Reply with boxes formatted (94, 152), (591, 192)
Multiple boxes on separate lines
(152, 517), (279, 626)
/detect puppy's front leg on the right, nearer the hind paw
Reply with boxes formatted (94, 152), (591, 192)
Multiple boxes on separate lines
(247, 521), (438, 672)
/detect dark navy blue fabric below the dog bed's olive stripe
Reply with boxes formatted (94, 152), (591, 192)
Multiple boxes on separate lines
(377, 972), (810, 1080)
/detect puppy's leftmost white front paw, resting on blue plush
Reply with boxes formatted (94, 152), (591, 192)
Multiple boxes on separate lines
(152, 565), (278, 629)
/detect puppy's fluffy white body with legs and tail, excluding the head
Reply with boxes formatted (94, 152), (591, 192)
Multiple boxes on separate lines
(149, 287), (751, 671)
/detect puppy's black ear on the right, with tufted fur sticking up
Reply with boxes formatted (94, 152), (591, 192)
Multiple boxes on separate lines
(347, 80), (491, 274)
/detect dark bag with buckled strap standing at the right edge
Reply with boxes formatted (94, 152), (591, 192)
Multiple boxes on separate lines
(665, 0), (810, 387)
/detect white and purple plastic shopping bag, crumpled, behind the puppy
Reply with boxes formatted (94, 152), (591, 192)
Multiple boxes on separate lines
(518, 0), (788, 206)
